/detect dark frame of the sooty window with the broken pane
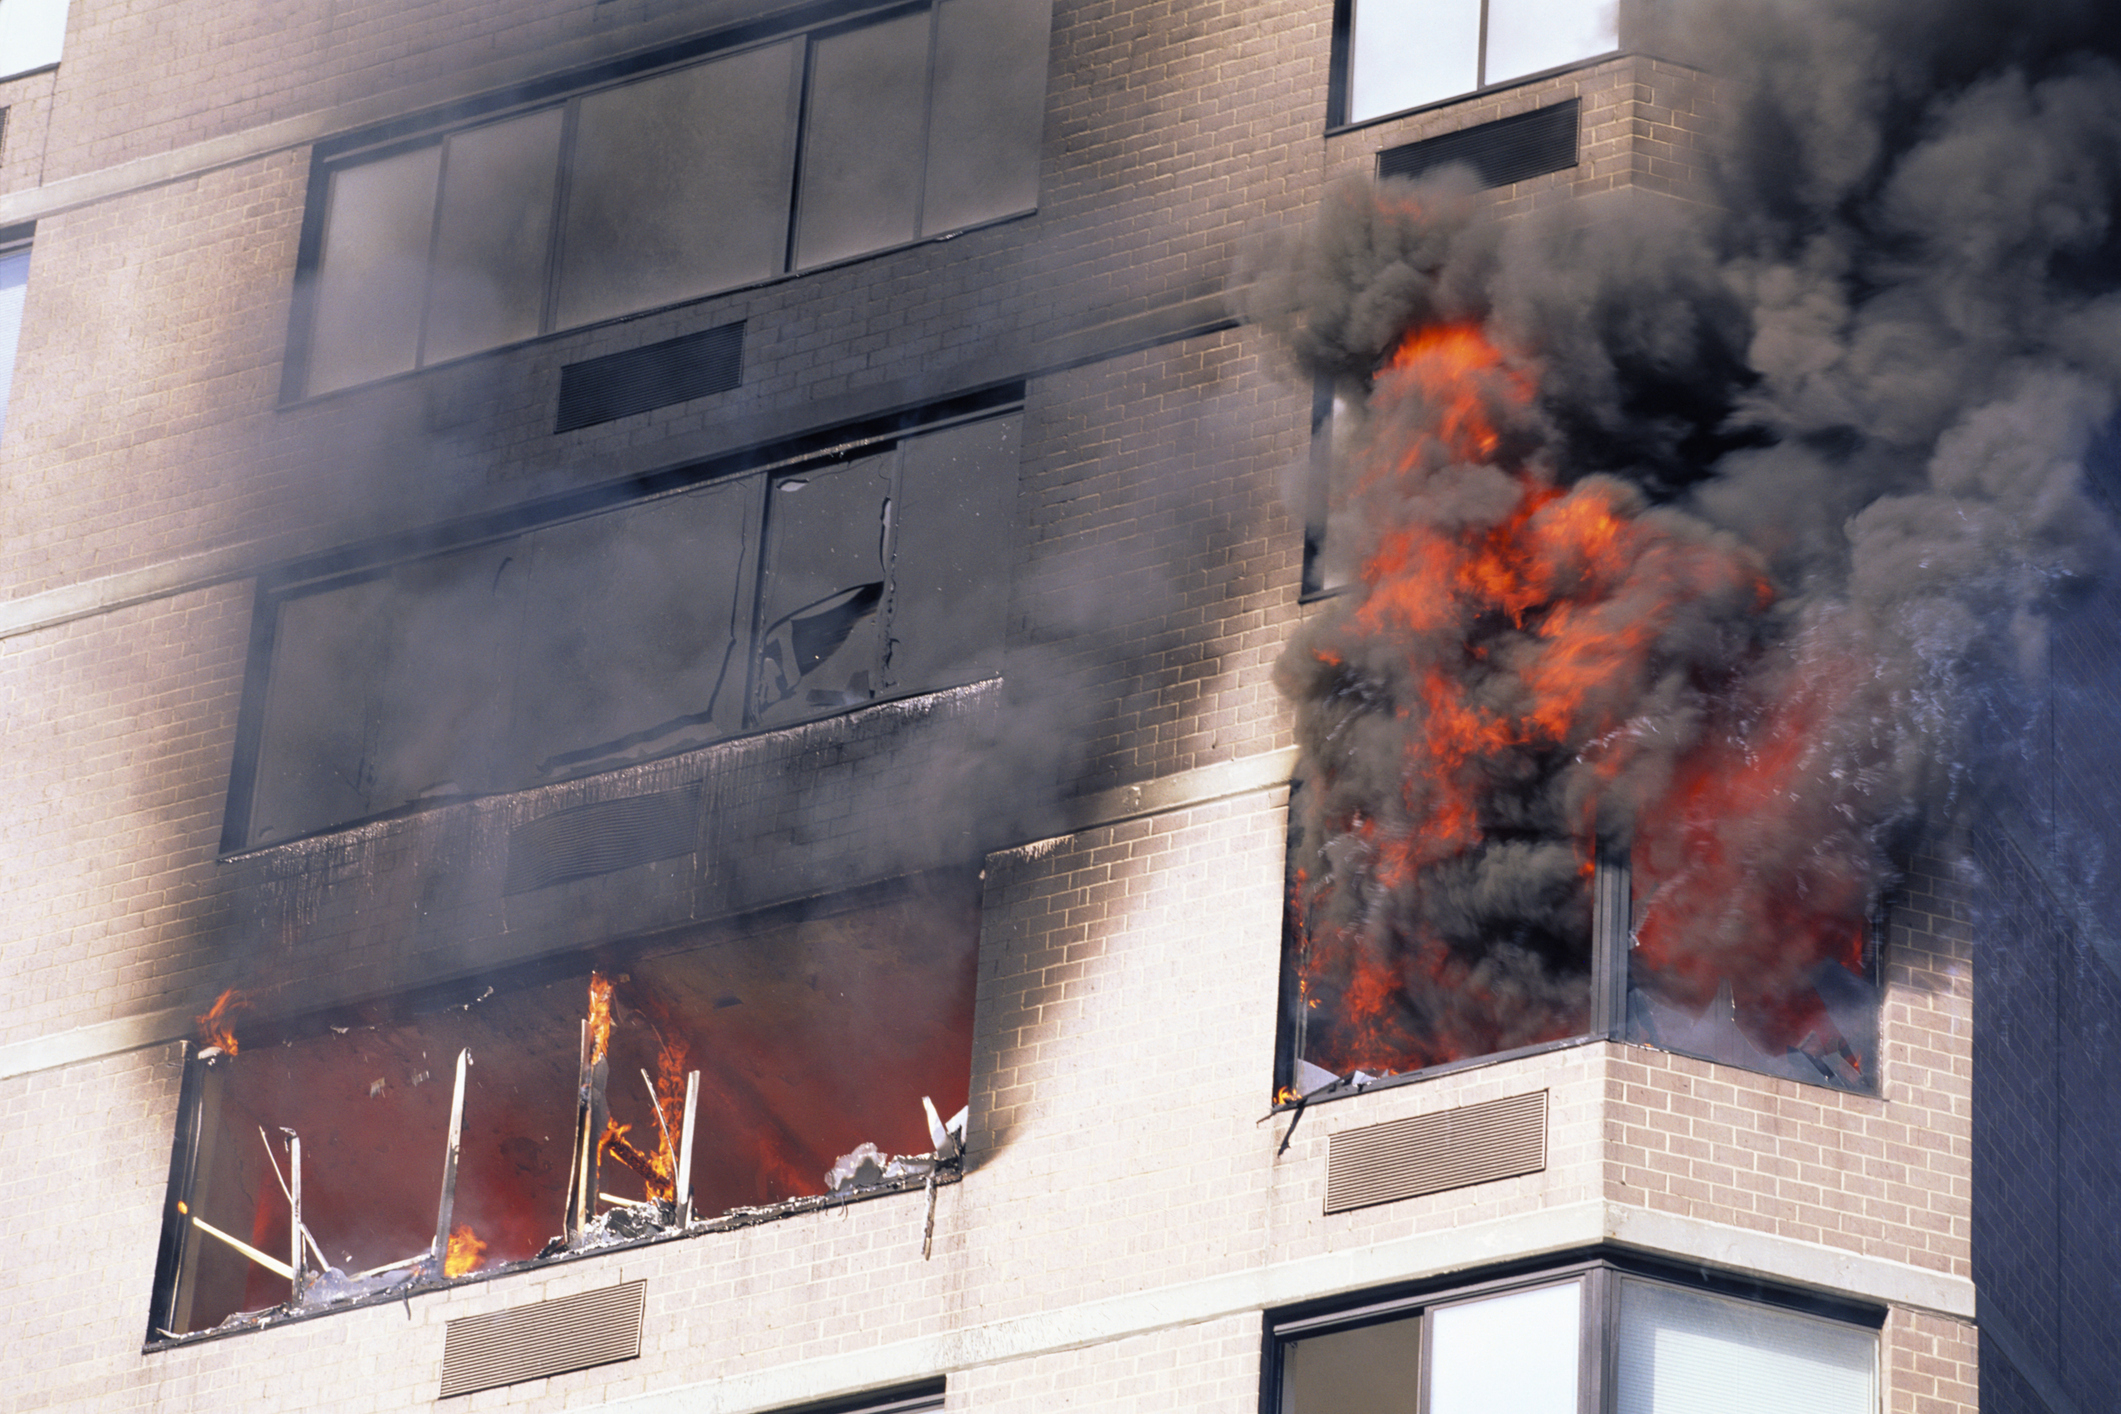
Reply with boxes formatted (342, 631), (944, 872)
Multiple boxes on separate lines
(218, 379), (1024, 859)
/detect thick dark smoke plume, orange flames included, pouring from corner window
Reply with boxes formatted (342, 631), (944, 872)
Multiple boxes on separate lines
(1258, 0), (2121, 1071)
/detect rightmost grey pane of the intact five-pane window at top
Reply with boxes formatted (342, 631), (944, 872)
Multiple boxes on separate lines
(921, 0), (1052, 235)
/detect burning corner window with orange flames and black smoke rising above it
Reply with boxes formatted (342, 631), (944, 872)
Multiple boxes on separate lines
(1277, 322), (1888, 1102)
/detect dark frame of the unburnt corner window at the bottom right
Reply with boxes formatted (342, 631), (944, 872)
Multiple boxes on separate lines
(1260, 1247), (1888, 1414)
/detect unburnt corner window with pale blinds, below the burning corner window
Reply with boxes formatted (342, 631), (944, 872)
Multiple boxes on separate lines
(1262, 1257), (1883, 1414)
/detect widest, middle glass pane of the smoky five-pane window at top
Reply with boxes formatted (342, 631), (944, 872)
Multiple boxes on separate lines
(558, 40), (802, 329)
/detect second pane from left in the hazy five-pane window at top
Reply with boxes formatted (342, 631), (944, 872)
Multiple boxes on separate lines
(420, 108), (564, 363)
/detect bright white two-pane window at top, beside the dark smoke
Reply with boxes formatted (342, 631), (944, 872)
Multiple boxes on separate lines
(1338, 0), (1618, 123)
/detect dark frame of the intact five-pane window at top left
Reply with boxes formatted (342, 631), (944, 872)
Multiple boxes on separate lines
(278, 0), (1050, 407)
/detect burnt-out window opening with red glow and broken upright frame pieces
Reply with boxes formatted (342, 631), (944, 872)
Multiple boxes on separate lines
(151, 876), (980, 1344)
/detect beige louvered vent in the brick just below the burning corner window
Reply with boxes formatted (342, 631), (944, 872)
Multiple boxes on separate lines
(1326, 1090), (1546, 1213)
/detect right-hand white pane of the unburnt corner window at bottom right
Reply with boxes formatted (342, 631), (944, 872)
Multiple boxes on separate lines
(1616, 1278), (1877, 1414)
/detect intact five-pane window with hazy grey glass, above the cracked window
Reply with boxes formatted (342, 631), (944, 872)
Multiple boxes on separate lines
(294, 0), (1050, 396)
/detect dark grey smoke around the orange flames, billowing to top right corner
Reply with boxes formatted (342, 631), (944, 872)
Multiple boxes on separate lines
(1256, 0), (2121, 1072)
